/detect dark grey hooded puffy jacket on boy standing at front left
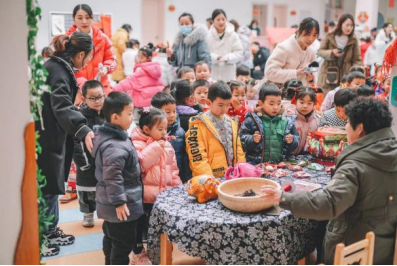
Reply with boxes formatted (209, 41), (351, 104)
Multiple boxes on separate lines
(92, 124), (143, 223)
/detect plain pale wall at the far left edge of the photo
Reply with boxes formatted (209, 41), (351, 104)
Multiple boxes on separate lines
(0, 0), (31, 265)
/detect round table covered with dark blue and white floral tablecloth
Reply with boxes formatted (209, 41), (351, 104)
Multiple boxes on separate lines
(148, 155), (331, 265)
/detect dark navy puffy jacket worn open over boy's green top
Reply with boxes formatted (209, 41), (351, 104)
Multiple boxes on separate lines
(240, 113), (299, 165)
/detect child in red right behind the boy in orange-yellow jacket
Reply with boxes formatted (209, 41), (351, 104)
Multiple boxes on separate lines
(227, 81), (251, 129)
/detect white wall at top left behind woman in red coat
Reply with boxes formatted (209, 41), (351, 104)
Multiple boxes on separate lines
(37, 0), (142, 49)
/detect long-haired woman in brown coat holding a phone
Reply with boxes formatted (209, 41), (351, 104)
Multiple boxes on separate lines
(318, 14), (363, 93)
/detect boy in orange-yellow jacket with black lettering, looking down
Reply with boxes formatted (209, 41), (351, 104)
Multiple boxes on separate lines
(186, 81), (245, 178)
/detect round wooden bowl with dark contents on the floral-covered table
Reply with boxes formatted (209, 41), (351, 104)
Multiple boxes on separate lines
(218, 178), (280, 213)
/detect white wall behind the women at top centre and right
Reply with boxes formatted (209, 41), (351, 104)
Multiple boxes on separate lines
(165, 0), (325, 42)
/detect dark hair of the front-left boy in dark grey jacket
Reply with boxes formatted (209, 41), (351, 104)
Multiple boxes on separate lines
(102, 92), (132, 123)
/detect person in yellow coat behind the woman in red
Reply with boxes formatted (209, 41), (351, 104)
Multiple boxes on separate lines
(112, 24), (132, 82)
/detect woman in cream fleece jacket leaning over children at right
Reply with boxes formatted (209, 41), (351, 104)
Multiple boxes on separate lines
(265, 18), (320, 88)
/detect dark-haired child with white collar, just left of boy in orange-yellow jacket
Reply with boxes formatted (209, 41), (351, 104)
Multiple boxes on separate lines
(173, 79), (202, 132)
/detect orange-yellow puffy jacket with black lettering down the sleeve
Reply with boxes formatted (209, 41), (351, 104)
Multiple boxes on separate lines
(186, 114), (245, 178)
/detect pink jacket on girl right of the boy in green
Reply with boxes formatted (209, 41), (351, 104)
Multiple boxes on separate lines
(285, 108), (321, 155)
